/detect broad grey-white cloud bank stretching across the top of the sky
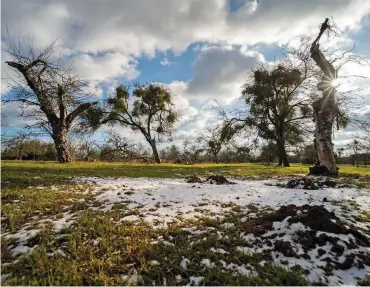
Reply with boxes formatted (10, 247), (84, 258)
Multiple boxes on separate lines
(2, 0), (370, 56)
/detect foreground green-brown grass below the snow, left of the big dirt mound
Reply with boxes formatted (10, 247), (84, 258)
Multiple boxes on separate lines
(2, 210), (308, 285)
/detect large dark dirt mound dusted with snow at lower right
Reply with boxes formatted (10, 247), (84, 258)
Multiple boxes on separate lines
(244, 205), (370, 280)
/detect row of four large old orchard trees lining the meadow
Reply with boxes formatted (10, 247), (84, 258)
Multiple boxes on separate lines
(4, 19), (368, 173)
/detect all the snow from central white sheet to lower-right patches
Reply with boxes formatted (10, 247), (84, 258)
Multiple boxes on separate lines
(71, 178), (370, 285)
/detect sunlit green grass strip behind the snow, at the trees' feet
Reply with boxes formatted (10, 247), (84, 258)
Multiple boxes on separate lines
(2, 161), (370, 181)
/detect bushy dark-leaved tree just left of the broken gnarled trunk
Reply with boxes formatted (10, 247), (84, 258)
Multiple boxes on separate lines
(242, 64), (311, 166)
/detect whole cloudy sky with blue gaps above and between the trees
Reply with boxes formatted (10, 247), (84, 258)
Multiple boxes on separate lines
(1, 0), (370, 152)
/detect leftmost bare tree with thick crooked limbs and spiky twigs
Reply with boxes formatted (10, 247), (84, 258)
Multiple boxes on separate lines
(4, 34), (96, 163)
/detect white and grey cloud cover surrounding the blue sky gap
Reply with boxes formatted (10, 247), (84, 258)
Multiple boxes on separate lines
(1, 0), (370, 150)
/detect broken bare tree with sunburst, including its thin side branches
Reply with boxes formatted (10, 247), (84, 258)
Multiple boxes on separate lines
(310, 18), (369, 175)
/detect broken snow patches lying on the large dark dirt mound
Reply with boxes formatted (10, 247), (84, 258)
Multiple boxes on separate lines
(237, 217), (370, 286)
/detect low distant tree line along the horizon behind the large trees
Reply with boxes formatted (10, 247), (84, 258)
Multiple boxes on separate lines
(2, 131), (370, 166)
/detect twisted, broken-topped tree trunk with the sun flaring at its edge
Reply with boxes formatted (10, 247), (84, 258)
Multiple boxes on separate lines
(310, 19), (338, 175)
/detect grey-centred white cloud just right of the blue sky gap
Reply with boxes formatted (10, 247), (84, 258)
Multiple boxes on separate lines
(164, 46), (265, 104)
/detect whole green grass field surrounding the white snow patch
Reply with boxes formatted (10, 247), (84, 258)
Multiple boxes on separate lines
(1, 161), (370, 285)
